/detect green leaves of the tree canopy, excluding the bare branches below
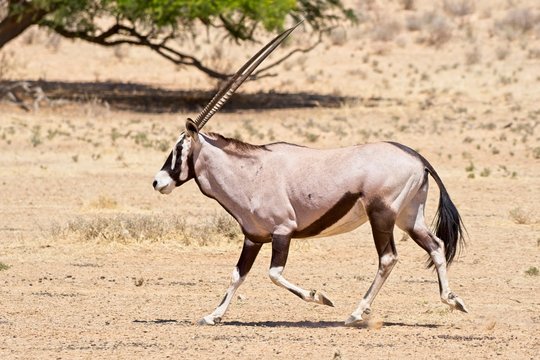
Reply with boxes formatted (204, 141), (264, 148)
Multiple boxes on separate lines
(22, 0), (356, 40)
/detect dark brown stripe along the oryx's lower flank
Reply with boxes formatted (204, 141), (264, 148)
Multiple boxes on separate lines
(293, 192), (362, 238)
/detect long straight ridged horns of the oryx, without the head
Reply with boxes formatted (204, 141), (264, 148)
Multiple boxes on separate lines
(195, 21), (302, 129)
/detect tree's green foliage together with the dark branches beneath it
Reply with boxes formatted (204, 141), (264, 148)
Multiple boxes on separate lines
(4, 0), (356, 79)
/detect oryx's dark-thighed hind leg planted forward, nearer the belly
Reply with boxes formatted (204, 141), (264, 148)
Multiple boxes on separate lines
(345, 206), (397, 326)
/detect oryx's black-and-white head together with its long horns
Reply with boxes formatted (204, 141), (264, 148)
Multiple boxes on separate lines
(153, 22), (301, 194)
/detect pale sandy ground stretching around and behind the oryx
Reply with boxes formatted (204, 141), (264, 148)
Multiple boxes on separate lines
(0, 1), (540, 359)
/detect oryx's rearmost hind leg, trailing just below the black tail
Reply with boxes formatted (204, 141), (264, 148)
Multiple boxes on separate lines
(396, 194), (468, 312)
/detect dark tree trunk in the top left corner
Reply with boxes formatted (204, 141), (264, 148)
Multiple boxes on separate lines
(0, 1), (47, 49)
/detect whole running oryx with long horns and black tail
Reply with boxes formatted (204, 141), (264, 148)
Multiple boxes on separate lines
(153, 24), (467, 325)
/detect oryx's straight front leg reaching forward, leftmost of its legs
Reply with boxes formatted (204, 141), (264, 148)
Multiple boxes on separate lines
(199, 238), (262, 325)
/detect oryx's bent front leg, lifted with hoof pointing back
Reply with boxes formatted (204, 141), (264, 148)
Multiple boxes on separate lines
(268, 234), (334, 306)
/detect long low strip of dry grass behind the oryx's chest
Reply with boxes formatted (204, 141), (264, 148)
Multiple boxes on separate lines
(49, 214), (242, 246)
